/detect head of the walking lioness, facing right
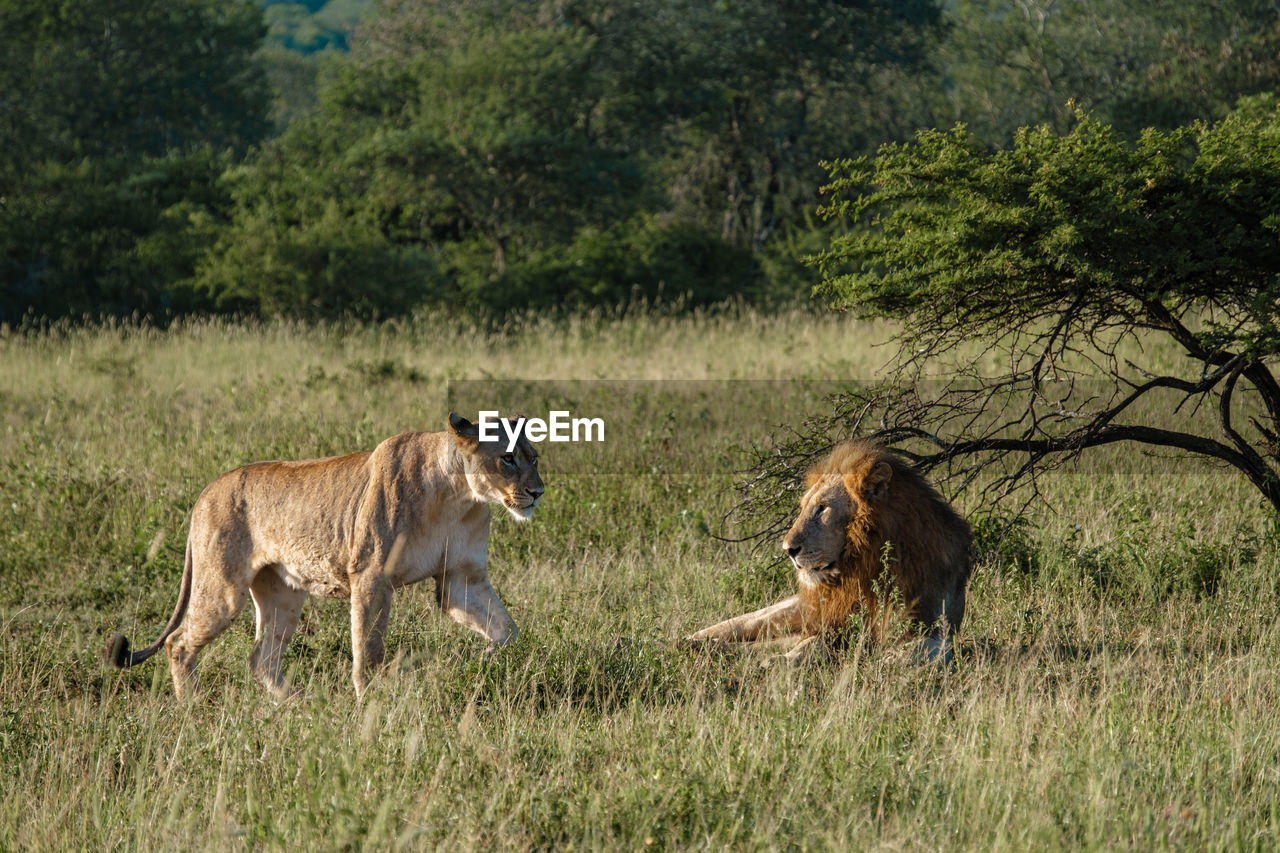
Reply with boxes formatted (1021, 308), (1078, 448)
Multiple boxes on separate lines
(449, 412), (547, 521)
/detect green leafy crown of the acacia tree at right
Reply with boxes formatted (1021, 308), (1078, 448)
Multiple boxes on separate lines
(817, 100), (1280, 338)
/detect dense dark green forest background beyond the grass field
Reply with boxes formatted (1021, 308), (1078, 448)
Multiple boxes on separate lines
(0, 0), (1280, 324)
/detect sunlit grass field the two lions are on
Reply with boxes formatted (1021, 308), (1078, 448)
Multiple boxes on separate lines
(0, 310), (1280, 850)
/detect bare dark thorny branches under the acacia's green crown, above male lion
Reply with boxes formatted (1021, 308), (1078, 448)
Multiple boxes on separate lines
(728, 323), (1280, 542)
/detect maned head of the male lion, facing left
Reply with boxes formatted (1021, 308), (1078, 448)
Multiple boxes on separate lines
(782, 442), (893, 585)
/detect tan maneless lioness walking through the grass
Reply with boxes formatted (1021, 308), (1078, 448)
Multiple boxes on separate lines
(106, 414), (545, 695)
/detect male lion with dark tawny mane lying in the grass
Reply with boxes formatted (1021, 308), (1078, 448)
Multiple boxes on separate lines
(687, 439), (972, 661)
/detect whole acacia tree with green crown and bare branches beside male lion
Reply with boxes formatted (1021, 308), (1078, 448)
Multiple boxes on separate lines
(748, 97), (1280, 525)
